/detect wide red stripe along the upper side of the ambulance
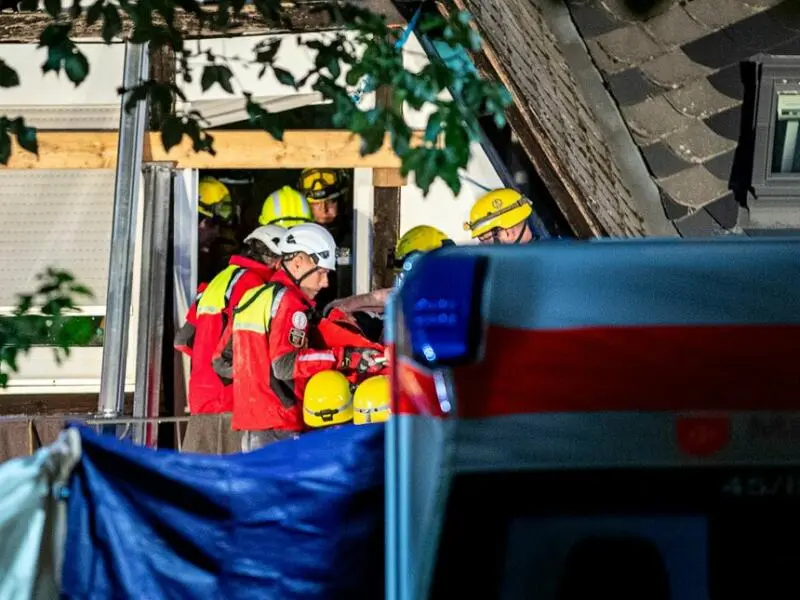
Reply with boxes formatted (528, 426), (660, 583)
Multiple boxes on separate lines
(382, 325), (800, 418)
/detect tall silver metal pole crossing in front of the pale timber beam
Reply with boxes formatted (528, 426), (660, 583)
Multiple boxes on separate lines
(97, 43), (149, 417)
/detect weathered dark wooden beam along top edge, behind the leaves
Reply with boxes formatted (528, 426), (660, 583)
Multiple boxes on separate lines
(0, 0), (406, 43)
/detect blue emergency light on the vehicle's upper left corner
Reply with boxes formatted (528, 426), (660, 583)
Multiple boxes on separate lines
(399, 250), (486, 366)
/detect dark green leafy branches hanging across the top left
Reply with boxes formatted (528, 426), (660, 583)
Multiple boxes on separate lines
(0, 0), (511, 193)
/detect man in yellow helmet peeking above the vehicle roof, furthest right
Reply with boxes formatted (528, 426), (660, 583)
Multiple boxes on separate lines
(464, 188), (534, 244)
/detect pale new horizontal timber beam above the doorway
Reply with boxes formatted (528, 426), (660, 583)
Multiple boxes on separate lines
(0, 130), (423, 170)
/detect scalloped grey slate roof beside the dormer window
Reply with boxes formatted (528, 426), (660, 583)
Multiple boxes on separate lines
(569, 0), (800, 236)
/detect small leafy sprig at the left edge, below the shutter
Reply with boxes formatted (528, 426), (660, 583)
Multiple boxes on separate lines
(0, 269), (96, 387)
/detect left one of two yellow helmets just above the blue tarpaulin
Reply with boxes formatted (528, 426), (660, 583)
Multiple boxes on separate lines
(303, 371), (353, 427)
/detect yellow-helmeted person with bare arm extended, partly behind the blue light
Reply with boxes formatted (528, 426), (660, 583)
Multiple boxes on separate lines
(325, 225), (455, 341)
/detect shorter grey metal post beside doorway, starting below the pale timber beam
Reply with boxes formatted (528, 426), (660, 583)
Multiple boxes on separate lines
(133, 163), (172, 447)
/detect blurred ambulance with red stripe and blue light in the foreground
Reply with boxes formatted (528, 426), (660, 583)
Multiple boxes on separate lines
(386, 238), (800, 600)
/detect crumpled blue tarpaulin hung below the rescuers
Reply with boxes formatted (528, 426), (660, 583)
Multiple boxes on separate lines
(62, 425), (384, 600)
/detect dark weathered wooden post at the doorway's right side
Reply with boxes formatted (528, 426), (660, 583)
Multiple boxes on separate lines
(372, 88), (405, 289)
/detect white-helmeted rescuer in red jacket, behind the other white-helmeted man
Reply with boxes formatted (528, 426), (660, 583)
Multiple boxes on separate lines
(175, 225), (286, 414)
